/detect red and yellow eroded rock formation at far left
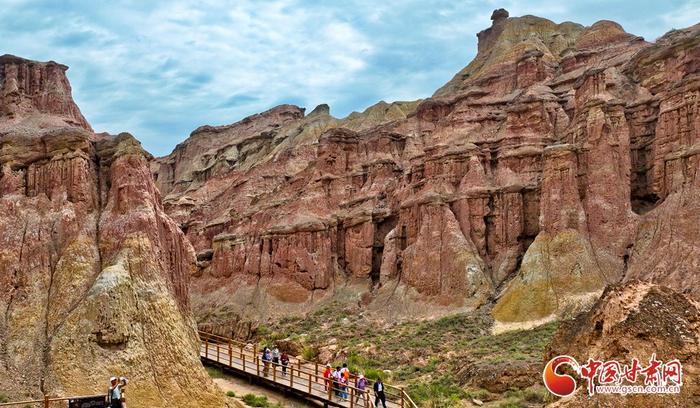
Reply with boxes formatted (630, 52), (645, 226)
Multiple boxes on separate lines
(0, 57), (224, 407)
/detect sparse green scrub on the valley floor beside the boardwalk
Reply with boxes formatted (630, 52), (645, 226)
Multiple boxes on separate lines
(258, 302), (557, 407)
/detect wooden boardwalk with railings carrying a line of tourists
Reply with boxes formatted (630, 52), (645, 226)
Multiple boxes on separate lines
(199, 332), (417, 408)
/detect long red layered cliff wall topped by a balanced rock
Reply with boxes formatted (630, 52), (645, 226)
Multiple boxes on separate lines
(152, 10), (700, 328)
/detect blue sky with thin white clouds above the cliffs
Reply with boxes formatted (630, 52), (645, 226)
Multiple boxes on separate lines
(0, 0), (700, 156)
